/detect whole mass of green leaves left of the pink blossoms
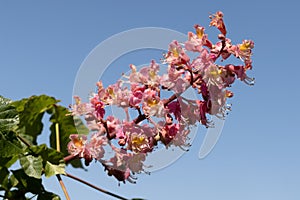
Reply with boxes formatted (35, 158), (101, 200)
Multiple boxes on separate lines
(0, 95), (83, 199)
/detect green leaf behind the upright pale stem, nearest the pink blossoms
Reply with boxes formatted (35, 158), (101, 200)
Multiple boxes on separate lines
(50, 106), (89, 168)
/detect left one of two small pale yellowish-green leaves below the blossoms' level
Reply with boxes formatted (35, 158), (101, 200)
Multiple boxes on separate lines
(19, 155), (43, 179)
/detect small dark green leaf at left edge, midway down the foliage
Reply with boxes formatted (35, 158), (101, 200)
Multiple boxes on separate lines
(0, 131), (23, 158)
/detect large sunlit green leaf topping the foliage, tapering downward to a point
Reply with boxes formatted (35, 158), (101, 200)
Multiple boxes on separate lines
(12, 95), (59, 144)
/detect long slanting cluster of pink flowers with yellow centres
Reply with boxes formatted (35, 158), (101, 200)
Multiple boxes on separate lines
(68, 11), (254, 182)
